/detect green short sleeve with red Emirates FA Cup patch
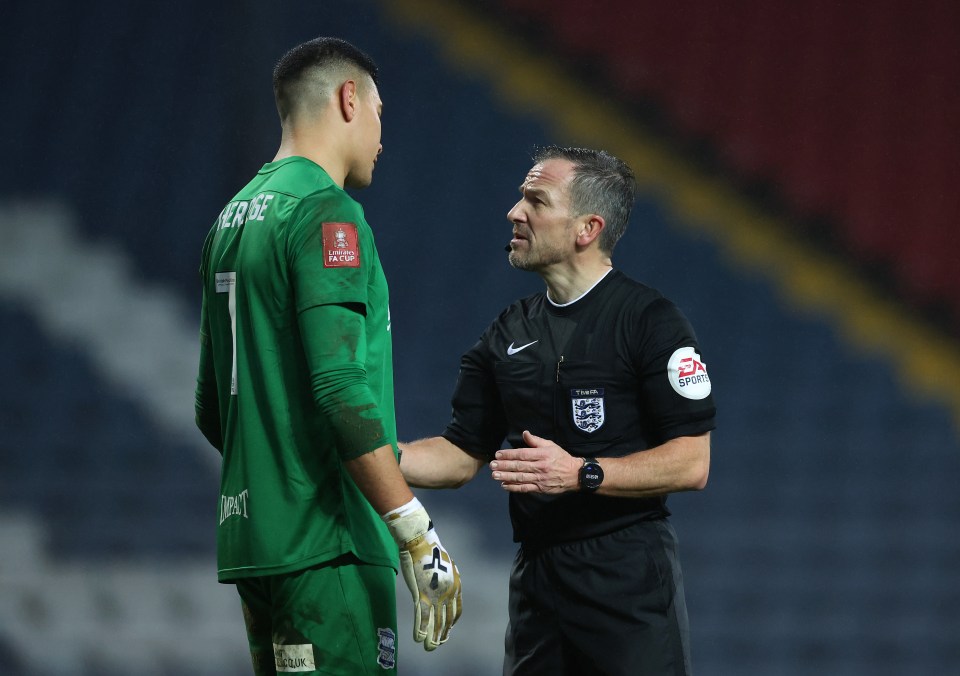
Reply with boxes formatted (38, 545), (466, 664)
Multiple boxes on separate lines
(287, 193), (374, 312)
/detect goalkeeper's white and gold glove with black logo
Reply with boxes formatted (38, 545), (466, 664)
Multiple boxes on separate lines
(383, 498), (463, 650)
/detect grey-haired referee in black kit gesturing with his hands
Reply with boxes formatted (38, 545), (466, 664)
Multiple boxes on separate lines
(400, 146), (715, 676)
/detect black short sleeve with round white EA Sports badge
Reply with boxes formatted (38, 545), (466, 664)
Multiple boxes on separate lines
(635, 298), (716, 443)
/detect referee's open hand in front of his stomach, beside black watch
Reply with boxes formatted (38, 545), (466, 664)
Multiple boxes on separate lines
(490, 431), (583, 493)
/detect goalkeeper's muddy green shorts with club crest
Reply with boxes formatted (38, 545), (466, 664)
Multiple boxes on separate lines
(236, 555), (397, 676)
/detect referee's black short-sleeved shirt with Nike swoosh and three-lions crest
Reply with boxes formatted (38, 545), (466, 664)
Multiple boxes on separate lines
(443, 270), (715, 545)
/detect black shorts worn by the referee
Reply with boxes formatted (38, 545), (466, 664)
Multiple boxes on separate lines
(503, 519), (691, 676)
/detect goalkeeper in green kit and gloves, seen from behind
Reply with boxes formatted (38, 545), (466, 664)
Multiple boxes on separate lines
(196, 38), (462, 676)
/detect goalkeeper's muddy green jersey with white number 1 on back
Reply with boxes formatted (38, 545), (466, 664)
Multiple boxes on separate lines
(197, 157), (398, 581)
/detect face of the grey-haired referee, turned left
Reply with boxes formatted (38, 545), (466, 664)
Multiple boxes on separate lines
(507, 158), (577, 272)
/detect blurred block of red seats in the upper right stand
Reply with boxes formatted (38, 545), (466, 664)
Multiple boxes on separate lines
(498, 0), (960, 335)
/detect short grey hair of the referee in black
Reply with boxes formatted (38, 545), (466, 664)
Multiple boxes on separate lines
(533, 145), (637, 255)
